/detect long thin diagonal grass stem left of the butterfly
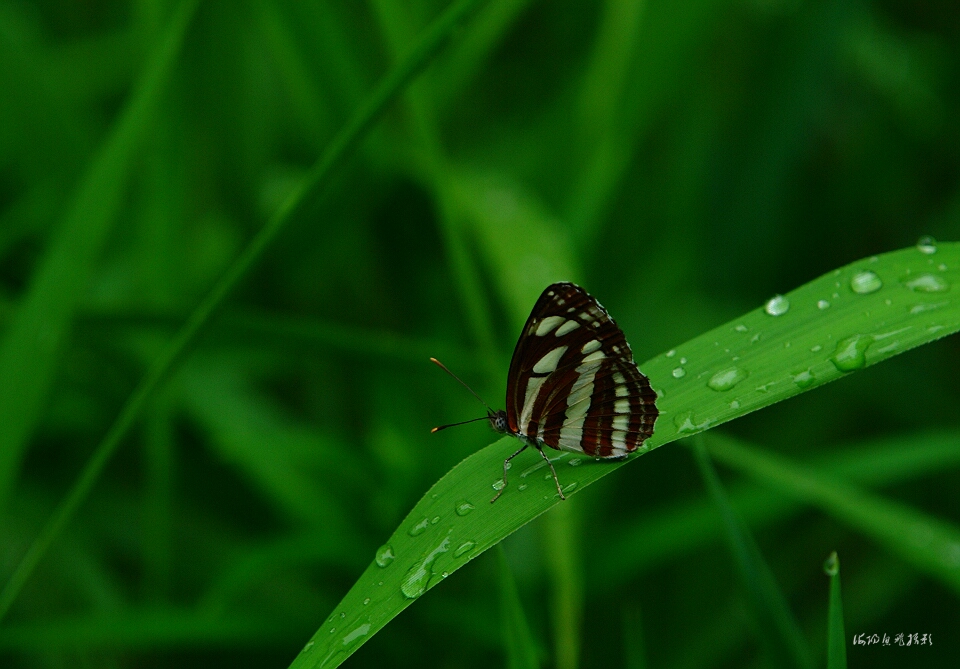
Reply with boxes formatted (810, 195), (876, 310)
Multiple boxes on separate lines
(0, 0), (492, 620)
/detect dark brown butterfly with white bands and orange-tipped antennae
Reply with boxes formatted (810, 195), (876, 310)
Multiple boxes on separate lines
(430, 282), (659, 503)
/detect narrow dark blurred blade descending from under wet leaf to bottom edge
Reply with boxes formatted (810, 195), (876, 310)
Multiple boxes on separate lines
(694, 438), (813, 668)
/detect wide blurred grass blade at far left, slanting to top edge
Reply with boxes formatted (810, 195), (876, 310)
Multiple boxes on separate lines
(0, 0), (198, 506)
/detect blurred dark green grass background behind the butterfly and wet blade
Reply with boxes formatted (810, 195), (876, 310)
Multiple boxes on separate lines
(0, 0), (960, 668)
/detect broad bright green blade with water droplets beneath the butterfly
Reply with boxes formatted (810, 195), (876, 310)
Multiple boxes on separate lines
(291, 243), (960, 669)
